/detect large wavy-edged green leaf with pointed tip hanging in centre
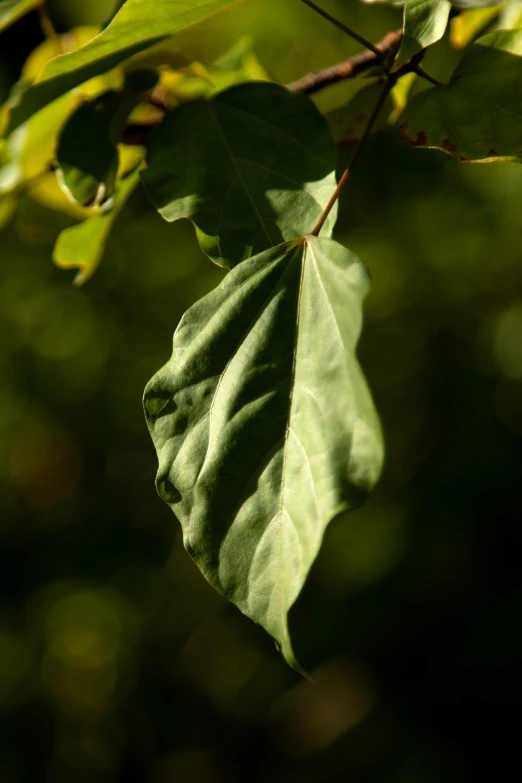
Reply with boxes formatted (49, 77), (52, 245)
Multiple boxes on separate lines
(144, 237), (383, 669)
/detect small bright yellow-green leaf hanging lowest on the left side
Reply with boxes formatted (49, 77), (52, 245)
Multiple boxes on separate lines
(53, 162), (139, 285)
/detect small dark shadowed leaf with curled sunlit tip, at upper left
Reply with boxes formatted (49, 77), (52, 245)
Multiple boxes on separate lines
(57, 71), (157, 206)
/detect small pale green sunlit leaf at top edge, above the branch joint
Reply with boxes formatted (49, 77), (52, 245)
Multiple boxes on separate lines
(397, 0), (451, 65)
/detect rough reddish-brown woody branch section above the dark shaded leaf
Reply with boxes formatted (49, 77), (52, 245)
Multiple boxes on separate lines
(286, 29), (402, 95)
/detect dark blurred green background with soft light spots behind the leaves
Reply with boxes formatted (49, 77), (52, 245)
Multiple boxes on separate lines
(0, 0), (522, 783)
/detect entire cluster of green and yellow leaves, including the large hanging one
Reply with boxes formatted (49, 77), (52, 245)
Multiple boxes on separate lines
(0, 0), (522, 668)
